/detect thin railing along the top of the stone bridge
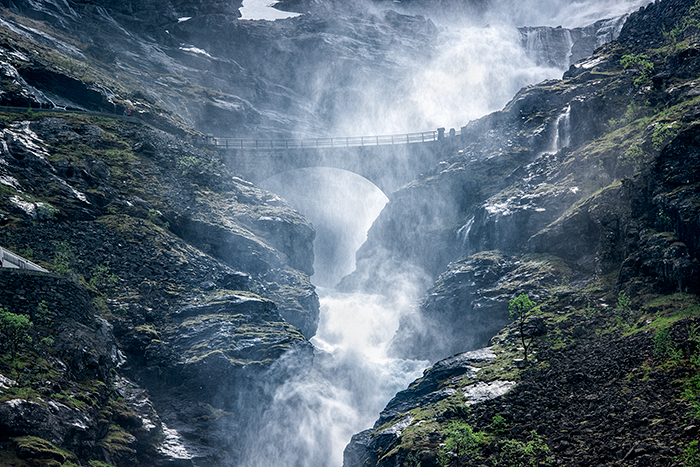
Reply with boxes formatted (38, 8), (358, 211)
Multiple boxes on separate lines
(209, 131), (442, 149)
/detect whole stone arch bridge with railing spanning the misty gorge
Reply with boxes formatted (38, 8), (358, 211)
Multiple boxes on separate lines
(215, 128), (460, 195)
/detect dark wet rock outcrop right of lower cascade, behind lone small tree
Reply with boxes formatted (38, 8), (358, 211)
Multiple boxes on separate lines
(391, 251), (571, 360)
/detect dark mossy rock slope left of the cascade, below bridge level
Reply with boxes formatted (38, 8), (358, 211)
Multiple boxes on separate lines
(0, 109), (319, 466)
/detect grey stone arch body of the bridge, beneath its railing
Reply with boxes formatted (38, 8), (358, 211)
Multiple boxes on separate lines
(217, 137), (458, 196)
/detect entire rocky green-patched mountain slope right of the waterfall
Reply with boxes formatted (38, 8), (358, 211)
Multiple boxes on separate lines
(344, 0), (700, 467)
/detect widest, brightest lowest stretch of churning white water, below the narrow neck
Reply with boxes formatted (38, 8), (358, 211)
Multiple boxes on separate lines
(242, 289), (427, 467)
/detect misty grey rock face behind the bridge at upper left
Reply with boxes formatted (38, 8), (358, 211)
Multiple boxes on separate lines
(2, 0), (437, 137)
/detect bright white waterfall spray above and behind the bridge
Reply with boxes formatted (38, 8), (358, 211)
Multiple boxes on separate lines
(328, 0), (649, 135)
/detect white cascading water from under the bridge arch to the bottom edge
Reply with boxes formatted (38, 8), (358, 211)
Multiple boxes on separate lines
(242, 169), (428, 467)
